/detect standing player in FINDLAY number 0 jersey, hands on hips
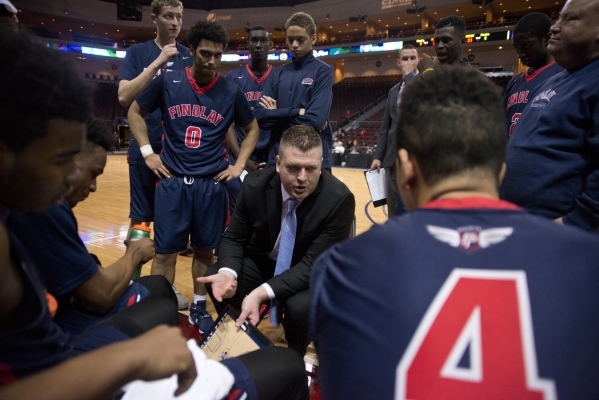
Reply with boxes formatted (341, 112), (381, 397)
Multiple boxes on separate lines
(129, 21), (258, 333)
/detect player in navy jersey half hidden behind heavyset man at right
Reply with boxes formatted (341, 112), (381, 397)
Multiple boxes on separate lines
(503, 13), (564, 136)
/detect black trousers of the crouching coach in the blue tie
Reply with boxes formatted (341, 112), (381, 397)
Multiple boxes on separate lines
(205, 257), (310, 355)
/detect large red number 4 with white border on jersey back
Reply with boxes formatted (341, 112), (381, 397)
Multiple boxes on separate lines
(395, 269), (557, 400)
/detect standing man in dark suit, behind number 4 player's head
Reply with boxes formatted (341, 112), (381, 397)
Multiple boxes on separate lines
(370, 44), (418, 217)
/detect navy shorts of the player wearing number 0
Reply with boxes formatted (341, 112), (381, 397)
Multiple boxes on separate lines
(154, 176), (230, 254)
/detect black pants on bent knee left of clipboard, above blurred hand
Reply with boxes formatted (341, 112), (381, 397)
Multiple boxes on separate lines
(99, 275), (178, 338)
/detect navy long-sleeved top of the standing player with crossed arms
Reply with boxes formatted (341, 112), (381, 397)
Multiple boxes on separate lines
(255, 54), (333, 168)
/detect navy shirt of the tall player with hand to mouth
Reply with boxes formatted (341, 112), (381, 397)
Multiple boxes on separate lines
(119, 40), (193, 165)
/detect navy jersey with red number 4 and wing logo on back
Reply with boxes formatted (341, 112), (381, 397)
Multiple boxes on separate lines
(310, 198), (599, 399)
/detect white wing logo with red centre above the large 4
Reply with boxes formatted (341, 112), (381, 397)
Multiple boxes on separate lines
(426, 225), (514, 253)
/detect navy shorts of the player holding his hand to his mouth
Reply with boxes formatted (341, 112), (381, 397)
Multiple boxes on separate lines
(129, 164), (158, 222)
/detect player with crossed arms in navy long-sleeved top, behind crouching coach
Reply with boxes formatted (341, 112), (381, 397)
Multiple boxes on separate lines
(254, 12), (333, 169)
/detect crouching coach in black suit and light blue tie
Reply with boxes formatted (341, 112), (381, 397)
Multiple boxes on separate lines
(198, 125), (355, 354)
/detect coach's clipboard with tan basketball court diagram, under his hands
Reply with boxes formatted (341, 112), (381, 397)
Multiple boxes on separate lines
(199, 305), (274, 361)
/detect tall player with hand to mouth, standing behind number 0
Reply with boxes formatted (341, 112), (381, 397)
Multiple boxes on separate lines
(118, 0), (192, 310)
